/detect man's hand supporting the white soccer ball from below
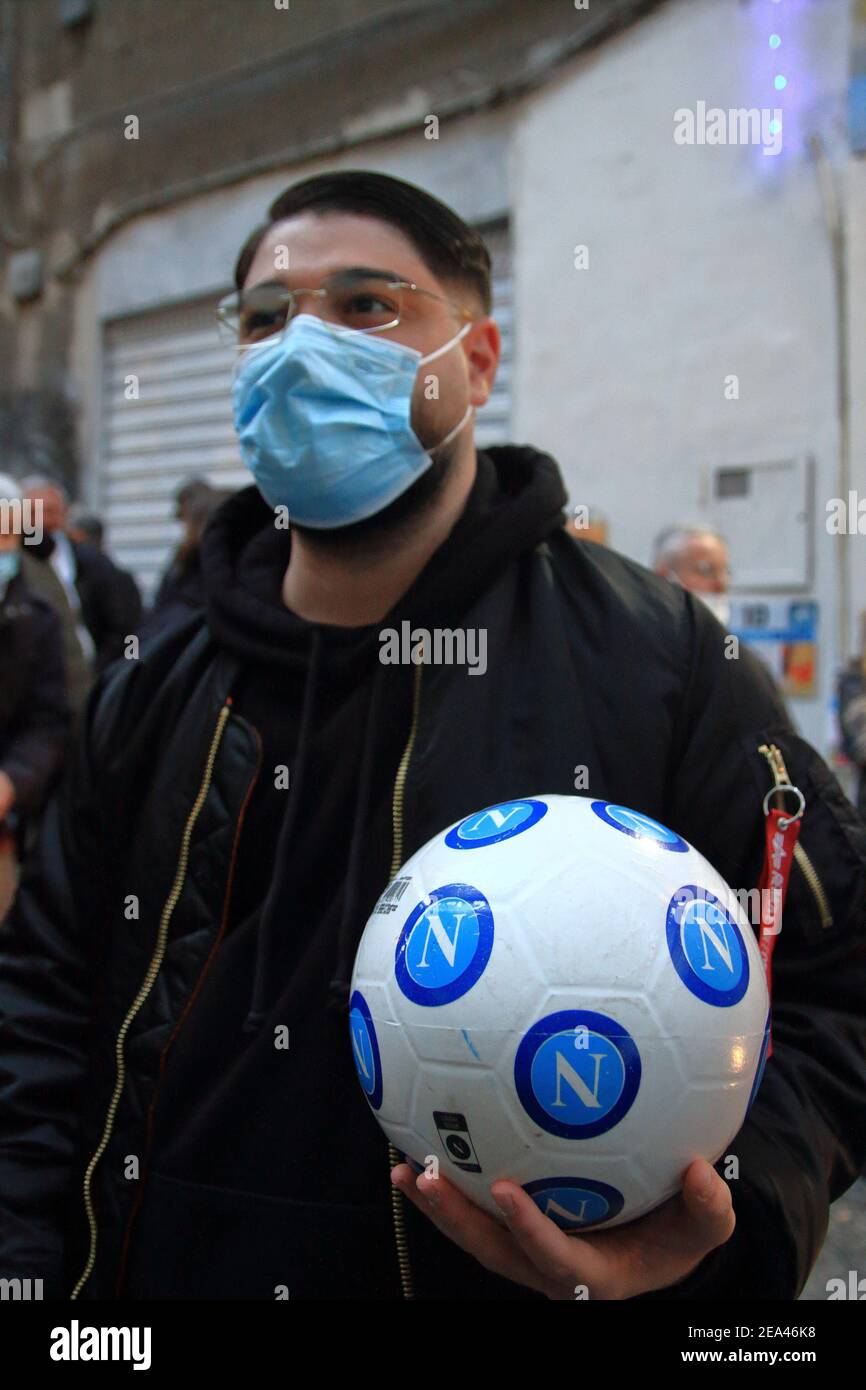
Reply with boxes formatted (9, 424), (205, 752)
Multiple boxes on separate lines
(391, 1158), (735, 1300)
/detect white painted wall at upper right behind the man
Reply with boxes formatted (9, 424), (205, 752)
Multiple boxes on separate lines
(510, 0), (866, 746)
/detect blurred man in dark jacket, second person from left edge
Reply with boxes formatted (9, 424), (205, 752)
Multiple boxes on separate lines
(24, 477), (142, 673)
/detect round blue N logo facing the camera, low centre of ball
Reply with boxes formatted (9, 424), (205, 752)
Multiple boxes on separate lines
(514, 1009), (641, 1138)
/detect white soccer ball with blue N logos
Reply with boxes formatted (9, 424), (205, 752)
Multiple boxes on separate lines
(349, 796), (770, 1232)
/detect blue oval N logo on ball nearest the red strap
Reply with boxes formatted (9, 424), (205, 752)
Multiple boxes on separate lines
(667, 884), (749, 1008)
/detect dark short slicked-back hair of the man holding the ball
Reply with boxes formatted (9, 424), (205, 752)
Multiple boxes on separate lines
(235, 170), (491, 314)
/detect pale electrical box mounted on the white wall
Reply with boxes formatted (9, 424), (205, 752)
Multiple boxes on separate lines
(706, 453), (813, 592)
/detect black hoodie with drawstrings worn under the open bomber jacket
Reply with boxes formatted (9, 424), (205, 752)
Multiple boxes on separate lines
(126, 448), (566, 1298)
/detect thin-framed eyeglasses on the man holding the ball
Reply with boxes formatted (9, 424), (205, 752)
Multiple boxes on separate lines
(217, 271), (474, 346)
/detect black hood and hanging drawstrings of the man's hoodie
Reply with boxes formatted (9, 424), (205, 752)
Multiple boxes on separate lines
(202, 446), (566, 1031)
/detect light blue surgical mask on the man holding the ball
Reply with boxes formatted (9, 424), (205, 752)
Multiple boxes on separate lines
(232, 314), (473, 530)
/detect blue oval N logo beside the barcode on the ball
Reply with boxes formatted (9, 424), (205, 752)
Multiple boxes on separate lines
(395, 883), (493, 1006)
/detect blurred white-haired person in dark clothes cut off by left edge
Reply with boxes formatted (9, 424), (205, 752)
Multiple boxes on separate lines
(0, 474), (70, 917)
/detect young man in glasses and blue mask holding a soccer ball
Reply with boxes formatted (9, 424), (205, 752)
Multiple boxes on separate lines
(0, 172), (866, 1298)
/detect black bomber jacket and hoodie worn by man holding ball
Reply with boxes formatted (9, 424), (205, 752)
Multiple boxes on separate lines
(0, 448), (866, 1298)
